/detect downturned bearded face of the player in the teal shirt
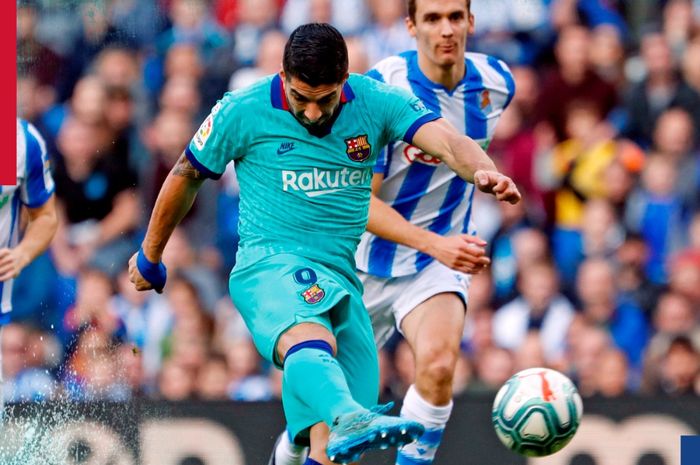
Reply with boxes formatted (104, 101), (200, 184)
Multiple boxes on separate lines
(282, 75), (345, 128)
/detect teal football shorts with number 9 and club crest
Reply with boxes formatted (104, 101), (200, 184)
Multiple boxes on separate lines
(229, 254), (379, 444)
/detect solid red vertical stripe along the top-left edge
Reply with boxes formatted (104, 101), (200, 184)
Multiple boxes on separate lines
(0, 0), (17, 186)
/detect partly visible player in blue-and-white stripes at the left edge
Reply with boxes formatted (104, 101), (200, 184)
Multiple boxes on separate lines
(0, 118), (58, 417)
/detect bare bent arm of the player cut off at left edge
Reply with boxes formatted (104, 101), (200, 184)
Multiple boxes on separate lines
(0, 194), (58, 282)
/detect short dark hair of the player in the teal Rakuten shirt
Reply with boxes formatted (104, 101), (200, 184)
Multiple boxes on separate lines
(282, 23), (348, 87)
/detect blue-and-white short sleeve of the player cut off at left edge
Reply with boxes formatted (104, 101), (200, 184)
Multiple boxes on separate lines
(20, 122), (55, 208)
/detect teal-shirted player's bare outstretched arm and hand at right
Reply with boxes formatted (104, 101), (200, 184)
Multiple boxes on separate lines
(412, 119), (521, 204)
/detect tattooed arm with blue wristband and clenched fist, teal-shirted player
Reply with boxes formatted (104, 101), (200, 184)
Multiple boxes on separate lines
(129, 153), (206, 292)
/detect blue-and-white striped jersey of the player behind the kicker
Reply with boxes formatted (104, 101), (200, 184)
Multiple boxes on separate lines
(355, 51), (515, 278)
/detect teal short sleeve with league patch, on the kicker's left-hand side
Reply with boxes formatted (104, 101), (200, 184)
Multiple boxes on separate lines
(185, 93), (240, 179)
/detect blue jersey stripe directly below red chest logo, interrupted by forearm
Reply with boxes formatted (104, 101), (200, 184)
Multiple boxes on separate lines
(368, 163), (435, 277)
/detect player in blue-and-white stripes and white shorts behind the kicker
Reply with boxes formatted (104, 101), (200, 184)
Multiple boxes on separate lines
(270, 0), (517, 465)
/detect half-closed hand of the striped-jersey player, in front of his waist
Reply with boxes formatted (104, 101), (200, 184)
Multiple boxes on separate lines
(428, 234), (491, 274)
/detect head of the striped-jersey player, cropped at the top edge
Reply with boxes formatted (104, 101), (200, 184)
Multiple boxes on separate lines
(406, 0), (474, 67)
